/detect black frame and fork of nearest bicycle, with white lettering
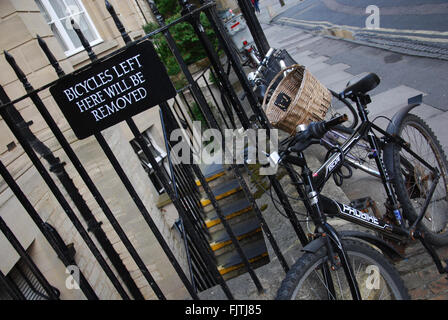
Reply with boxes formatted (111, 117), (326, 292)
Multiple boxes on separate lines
(286, 98), (444, 299)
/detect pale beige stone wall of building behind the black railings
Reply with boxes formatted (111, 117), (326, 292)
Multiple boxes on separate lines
(0, 0), (188, 299)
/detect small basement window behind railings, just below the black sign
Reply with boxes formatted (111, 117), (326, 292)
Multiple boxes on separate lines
(131, 129), (170, 194)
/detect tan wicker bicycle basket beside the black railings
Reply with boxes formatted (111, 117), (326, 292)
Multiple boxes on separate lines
(263, 64), (331, 134)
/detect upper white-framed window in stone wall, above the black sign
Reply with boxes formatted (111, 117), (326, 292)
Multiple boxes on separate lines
(35, 0), (102, 56)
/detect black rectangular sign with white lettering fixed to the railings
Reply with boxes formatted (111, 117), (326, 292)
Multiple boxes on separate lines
(50, 41), (176, 139)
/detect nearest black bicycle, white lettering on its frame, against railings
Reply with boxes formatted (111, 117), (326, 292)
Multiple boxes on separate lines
(248, 48), (448, 300)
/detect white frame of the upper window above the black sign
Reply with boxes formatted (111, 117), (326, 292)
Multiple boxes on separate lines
(36, 0), (103, 57)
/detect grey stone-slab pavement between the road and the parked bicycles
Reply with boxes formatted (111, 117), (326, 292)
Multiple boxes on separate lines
(240, 0), (448, 300)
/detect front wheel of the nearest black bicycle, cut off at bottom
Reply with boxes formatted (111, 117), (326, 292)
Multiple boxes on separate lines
(276, 240), (410, 300)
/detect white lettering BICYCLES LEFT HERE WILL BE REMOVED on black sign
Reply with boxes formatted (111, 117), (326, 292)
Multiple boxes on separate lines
(59, 54), (148, 122)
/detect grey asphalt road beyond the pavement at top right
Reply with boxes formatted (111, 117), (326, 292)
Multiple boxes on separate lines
(274, 0), (448, 59)
